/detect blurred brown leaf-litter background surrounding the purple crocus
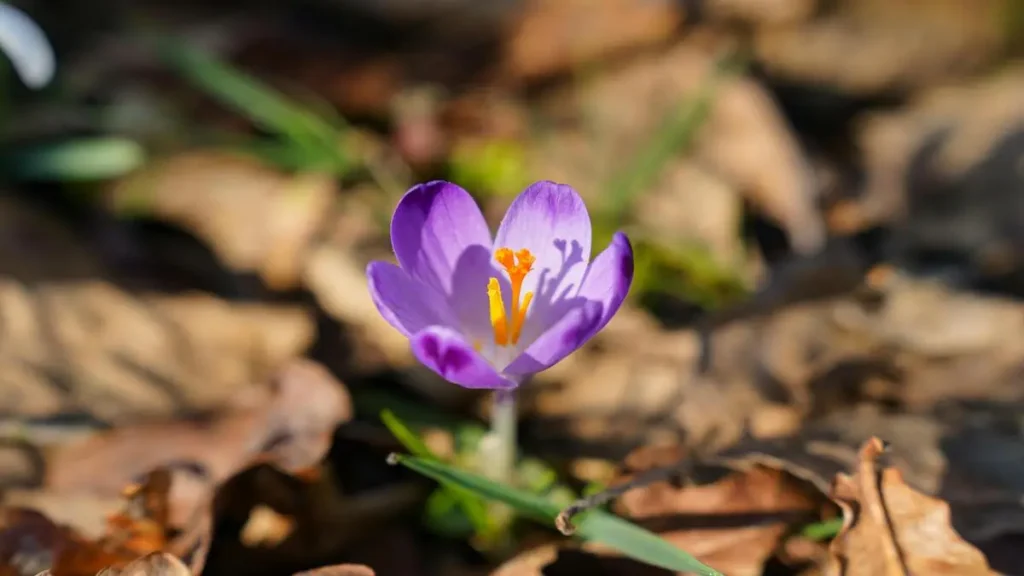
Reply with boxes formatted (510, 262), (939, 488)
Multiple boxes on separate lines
(0, 0), (1024, 576)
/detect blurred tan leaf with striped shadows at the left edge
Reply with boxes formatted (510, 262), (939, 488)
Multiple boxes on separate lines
(0, 280), (313, 423)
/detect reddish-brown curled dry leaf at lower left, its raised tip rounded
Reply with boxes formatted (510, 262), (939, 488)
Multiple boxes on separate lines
(46, 360), (351, 526)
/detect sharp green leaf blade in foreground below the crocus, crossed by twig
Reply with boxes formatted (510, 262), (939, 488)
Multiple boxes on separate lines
(392, 454), (723, 576)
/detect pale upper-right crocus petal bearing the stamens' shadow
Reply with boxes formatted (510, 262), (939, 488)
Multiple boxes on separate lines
(495, 181), (591, 315)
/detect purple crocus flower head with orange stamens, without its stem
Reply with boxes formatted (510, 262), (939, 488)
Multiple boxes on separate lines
(367, 180), (633, 389)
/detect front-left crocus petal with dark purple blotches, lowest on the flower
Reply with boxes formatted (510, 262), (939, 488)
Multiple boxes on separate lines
(412, 326), (516, 389)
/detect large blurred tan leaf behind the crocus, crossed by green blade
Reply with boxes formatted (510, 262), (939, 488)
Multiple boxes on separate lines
(527, 35), (824, 258)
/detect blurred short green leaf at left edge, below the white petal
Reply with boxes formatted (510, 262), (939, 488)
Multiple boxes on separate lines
(0, 137), (145, 181)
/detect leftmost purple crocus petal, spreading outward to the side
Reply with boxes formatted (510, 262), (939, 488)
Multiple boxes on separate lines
(367, 261), (455, 337)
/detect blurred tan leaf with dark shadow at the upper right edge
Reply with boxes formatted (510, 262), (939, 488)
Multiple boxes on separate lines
(851, 66), (1024, 293)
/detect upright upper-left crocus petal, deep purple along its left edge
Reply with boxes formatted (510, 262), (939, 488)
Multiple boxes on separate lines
(391, 180), (490, 297)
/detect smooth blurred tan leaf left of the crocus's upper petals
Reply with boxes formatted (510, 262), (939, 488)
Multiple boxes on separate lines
(110, 152), (336, 290)
